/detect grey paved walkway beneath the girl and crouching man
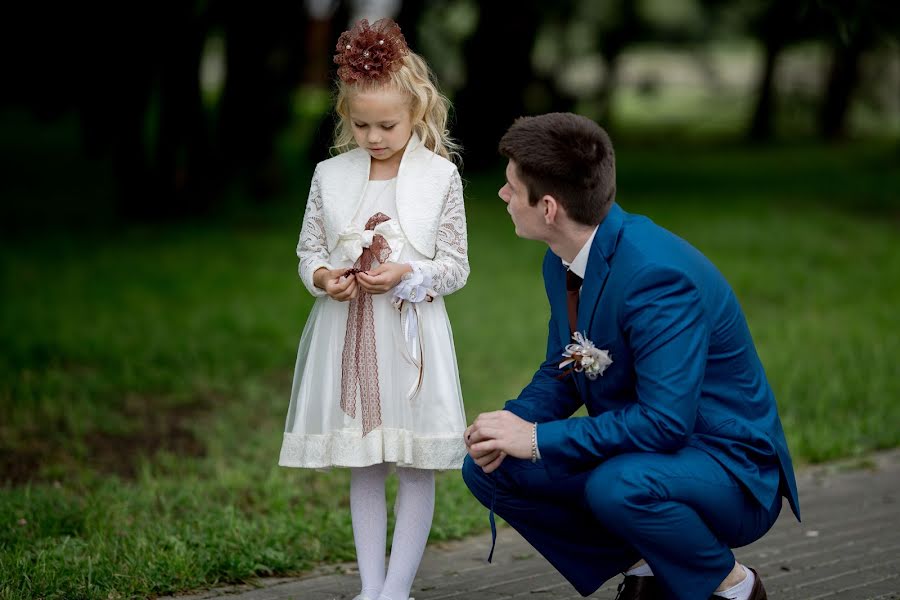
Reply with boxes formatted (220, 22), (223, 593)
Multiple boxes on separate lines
(168, 451), (900, 600)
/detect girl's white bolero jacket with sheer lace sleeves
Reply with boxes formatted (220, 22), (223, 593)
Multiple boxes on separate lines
(297, 133), (469, 296)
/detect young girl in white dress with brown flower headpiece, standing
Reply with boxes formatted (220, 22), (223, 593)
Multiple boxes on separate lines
(279, 19), (469, 600)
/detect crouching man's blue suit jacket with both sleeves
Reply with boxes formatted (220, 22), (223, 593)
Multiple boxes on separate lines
(506, 204), (800, 519)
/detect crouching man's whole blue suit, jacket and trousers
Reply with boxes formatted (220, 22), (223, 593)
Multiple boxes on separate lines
(463, 204), (799, 599)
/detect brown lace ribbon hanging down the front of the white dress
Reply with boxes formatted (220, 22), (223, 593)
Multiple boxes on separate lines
(341, 213), (391, 436)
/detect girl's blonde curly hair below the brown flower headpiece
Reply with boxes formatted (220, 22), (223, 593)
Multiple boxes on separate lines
(331, 51), (461, 165)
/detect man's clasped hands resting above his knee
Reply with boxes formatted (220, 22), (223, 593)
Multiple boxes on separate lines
(465, 410), (534, 473)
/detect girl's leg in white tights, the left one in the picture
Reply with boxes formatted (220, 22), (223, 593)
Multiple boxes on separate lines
(350, 463), (388, 600)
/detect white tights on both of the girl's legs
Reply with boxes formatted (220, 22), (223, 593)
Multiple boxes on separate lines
(350, 463), (434, 600)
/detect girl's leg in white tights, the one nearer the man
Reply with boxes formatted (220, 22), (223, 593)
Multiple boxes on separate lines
(380, 468), (434, 600)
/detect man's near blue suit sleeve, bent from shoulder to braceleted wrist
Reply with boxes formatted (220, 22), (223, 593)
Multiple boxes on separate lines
(538, 266), (709, 475)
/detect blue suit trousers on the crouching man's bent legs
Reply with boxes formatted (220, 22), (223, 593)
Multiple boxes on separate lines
(462, 447), (781, 600)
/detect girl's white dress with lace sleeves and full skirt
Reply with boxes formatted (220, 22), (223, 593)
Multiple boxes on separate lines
(279, 176), (468, 469)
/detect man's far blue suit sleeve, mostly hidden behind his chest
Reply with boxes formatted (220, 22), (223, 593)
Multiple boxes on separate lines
(503, 253), (582, 422)
